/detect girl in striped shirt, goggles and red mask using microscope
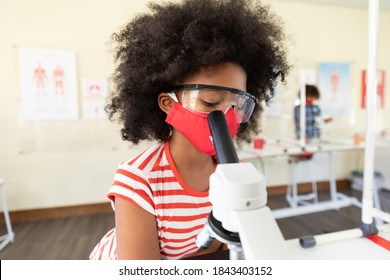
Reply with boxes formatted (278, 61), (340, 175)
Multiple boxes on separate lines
(90, 0), (289, 259)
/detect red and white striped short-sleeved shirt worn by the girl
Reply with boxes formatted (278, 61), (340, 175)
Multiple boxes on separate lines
(90, 141), (211, 259)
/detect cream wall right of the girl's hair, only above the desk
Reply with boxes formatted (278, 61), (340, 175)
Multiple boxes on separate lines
(264, 0), (390, 138)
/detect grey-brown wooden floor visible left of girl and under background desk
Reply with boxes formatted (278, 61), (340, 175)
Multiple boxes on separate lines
(0, 187), (390, 260)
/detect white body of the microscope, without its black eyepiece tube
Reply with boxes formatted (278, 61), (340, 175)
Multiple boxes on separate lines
(209, 163), (289, 260)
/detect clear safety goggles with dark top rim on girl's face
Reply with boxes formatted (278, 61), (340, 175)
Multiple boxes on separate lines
(168, 84), (258, 123)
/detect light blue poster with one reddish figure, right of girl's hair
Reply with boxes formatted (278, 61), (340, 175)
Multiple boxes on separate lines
(318, 63), (351, 116)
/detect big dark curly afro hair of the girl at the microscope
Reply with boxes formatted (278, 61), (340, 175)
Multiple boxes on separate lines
(106, 0), (289, 144)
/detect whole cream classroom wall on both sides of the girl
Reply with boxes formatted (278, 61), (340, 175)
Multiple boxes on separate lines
(0, 0), (390, 210)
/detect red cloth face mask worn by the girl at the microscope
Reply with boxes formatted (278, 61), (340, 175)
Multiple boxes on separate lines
(165, 102), (240, 156)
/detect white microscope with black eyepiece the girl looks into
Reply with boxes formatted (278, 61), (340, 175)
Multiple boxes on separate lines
(196, 111), (290, 260)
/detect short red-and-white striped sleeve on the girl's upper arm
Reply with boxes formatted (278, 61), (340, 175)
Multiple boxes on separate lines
(107, 163), (155, 215)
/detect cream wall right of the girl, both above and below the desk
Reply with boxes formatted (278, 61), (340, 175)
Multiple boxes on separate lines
(253, 0), (390, 185)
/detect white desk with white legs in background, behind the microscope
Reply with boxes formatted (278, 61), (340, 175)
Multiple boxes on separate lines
(238, 140), (364, 219)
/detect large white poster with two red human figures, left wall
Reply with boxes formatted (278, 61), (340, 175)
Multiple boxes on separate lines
(19, 49), (78, 121)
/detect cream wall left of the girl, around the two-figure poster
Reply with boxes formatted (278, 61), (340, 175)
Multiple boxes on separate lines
(0, 0), (155, 210)
